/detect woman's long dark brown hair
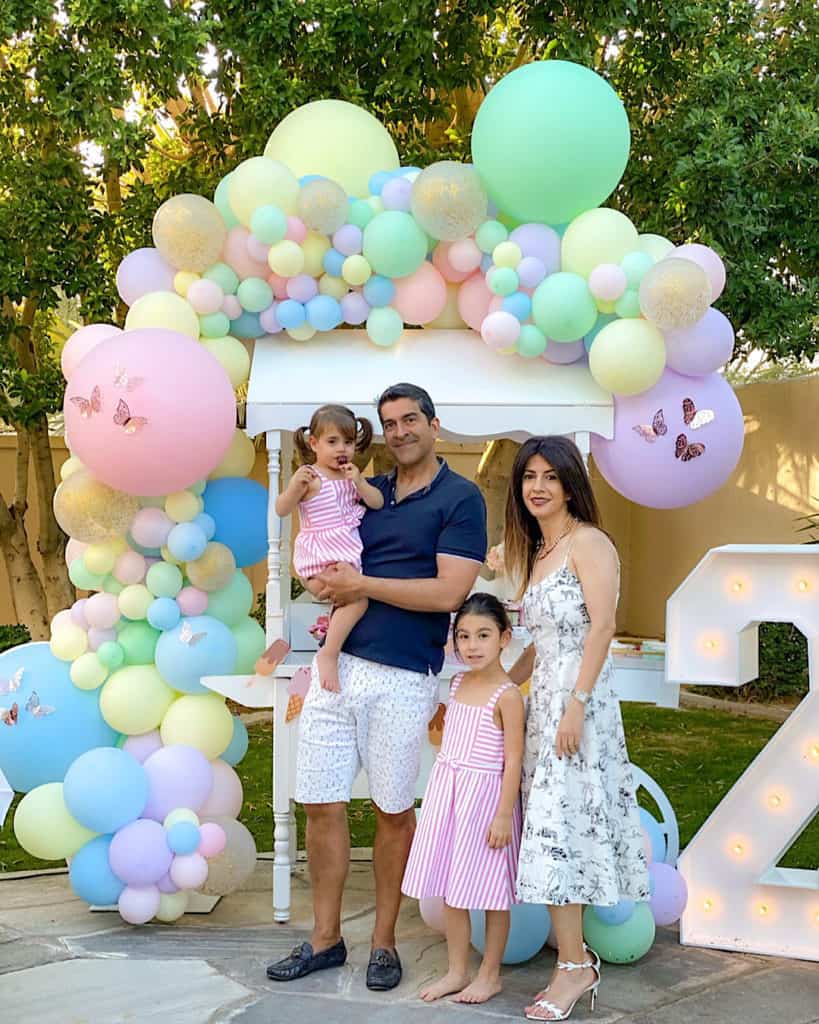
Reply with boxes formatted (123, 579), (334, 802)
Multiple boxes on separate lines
(504, 434), (602, 594)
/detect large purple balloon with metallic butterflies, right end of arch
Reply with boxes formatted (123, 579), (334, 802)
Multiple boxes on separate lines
(592, 370), (744, 509)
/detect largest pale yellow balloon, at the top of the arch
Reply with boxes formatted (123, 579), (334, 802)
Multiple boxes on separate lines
(266, 99), (400, 197)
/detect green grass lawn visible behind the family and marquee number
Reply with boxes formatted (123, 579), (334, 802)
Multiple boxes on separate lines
(0, 703), (819, 871)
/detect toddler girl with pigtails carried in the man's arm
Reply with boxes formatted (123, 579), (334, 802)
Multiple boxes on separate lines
(275, 406), (384, 692)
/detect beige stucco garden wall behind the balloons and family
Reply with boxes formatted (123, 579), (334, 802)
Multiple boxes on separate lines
(0, 376), (819, 636)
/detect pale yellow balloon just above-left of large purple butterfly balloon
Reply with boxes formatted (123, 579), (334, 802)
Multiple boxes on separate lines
(589, 318), (665, 395)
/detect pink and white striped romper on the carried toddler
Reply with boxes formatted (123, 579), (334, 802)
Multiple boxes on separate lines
(293, 470), (365, 580)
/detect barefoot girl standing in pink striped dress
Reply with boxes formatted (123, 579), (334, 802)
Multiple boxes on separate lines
(401, 594), (523, 1002)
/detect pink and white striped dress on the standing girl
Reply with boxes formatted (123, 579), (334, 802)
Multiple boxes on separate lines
(401, 674), (521, 910)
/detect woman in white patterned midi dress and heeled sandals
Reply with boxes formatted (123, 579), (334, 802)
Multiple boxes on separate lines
(505, 437), (649, 1021)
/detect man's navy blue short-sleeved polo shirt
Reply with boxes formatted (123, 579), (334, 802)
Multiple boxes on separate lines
(343, 459), (486, 674)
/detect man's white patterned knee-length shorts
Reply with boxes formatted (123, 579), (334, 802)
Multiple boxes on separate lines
(296, 653), (438, 814)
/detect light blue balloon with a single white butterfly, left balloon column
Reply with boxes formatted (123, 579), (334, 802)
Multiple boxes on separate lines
(156, 615), (238, 693)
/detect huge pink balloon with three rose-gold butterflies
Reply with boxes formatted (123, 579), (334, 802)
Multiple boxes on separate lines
(64, 328), (235, 495)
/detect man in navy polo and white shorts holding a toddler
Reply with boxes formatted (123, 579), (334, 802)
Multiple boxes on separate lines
(267, 384), (486, 991)
